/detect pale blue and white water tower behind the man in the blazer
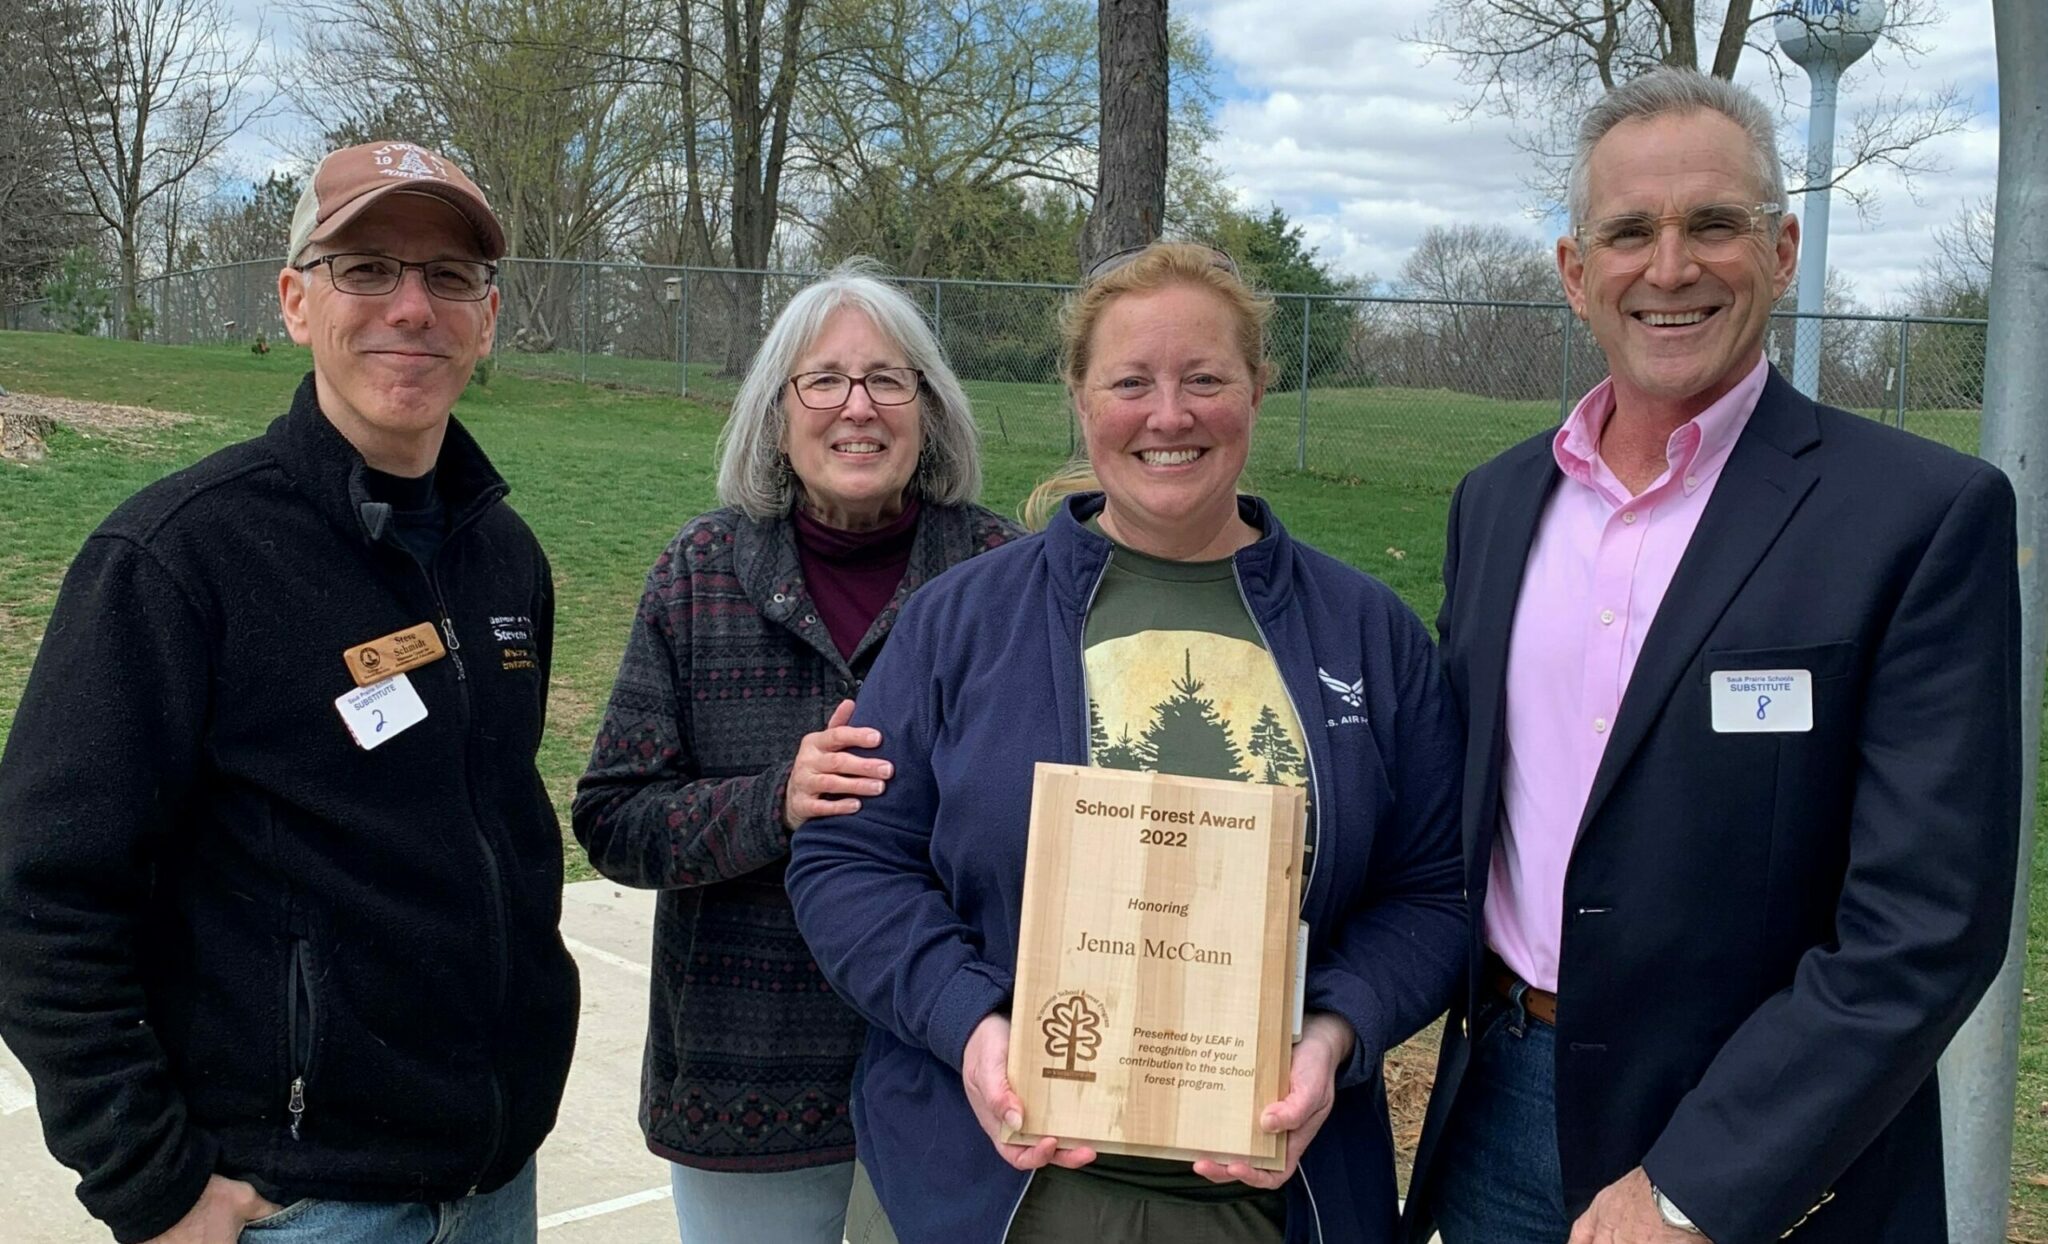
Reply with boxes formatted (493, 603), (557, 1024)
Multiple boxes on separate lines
(1774, 0), (1884, 398)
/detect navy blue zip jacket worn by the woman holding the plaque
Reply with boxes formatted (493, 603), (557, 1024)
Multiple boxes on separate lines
(788, 494), (1466, 1244)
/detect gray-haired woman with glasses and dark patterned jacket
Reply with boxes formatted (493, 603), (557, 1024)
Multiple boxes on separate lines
(573, 262), (1016, 1244)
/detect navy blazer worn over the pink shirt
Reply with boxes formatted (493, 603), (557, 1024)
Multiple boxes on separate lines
(1409, 369), (2019, 1244)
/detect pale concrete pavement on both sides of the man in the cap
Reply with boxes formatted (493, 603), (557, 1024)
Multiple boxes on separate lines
(0, 881), (676, 1244)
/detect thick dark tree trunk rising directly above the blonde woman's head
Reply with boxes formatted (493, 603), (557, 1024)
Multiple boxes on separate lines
(1081, 0), (1167, 273)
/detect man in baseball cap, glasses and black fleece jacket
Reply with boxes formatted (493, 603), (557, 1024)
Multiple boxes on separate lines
(0, 141), (578, 1244)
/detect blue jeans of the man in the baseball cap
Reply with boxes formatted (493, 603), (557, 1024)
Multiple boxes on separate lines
(242, 1158), (541, 1244)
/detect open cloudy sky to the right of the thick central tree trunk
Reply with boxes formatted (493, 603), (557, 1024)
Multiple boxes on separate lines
(1174, 0), (1999, 303)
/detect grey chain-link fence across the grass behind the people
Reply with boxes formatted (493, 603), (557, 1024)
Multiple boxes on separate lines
(0, 260), (1985, 492)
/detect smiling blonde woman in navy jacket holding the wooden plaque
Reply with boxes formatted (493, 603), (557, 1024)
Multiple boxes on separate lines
(788, 244), (1464, 1244)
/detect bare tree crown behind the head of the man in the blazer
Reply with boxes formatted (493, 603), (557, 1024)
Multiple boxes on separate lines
(1411, 0), (1970, 209)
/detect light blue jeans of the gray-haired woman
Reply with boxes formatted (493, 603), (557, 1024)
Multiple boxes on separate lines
(668, 1162), (854, 1244)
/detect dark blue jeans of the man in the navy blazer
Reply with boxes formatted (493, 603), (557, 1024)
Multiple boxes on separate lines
(1436, 998), (1571, 1244)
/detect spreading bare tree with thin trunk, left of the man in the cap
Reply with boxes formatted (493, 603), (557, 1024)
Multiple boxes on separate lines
(37, 0), (270, 338)
